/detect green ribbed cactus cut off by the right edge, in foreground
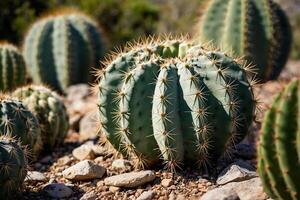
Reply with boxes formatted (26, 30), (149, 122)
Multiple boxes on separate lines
(258, 80), (300, 200)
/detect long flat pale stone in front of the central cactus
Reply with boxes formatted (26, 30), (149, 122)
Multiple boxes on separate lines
(104, 170), (155, 188)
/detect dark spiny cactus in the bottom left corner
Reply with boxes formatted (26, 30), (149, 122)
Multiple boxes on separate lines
(0, 136), (27, 199)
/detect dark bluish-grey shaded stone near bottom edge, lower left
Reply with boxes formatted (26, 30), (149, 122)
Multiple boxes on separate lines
(43, 183), (73, 198)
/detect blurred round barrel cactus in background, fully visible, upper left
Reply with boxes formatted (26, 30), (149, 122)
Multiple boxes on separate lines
(23, 11), (104, 91)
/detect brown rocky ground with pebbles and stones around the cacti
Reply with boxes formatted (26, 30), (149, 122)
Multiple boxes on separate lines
(22, 62), (300, 200)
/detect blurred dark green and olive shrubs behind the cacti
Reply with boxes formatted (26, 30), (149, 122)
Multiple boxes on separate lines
(0, 0), (300, 59)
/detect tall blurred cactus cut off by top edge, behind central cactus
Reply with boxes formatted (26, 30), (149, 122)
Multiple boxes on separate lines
(196, 0), (292, 81)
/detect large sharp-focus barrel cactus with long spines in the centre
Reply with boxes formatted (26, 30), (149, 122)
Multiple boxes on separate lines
(98, 40), (255, 169)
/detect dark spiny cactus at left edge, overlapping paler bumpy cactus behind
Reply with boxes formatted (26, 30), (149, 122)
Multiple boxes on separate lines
(0, 96), (41, 154)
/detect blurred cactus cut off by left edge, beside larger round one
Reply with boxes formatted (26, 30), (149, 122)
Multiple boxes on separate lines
(0, 43), (26, 91)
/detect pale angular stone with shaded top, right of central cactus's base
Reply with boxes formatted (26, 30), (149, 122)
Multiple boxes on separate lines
(217, 160), (258, 185)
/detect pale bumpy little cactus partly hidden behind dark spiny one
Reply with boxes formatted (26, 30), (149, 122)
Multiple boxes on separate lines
(12, 85), (69, 151)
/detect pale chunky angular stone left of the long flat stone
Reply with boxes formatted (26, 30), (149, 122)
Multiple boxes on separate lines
(62, 160), (106, 181)
